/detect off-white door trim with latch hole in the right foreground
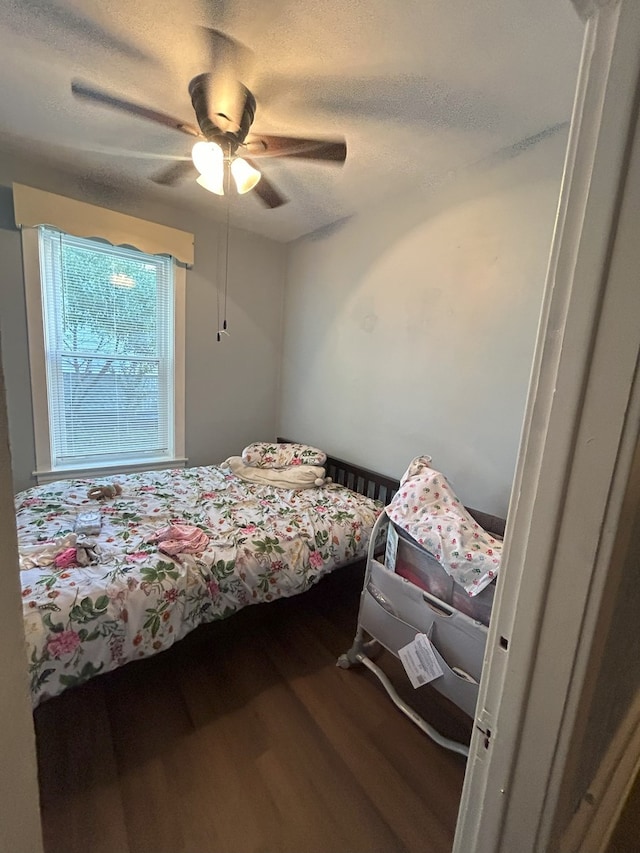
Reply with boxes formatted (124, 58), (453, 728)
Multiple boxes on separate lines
(454, 0), (640, 853)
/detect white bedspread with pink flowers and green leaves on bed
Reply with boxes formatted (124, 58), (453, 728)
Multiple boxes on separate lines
(16, 467), (381, 705)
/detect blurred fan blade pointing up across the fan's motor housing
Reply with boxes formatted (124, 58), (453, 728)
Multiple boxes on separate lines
(201, 27), (253, 133)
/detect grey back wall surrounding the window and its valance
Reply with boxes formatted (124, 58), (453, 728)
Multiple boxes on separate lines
(0, 152), (287, 489)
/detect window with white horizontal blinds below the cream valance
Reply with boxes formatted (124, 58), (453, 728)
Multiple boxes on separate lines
(23, 226), (185, 481)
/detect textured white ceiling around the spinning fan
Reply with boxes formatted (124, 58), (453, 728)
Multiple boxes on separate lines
(0, 0), (582, 240)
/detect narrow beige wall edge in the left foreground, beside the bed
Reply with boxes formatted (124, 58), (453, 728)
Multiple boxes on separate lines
(0, 350), (42, 853)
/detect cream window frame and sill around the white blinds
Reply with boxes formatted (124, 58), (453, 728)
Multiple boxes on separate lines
(22, 226), (188, 484)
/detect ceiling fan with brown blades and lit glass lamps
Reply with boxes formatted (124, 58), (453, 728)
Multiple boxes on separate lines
(71, 27), (347, 208)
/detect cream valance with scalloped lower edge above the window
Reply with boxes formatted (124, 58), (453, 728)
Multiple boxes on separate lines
(13, 184), (193, 266)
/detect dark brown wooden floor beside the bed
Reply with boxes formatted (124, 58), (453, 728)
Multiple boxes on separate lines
(35, 566), (470, 853)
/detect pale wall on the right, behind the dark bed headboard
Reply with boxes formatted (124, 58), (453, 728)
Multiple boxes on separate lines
(278, 128), (566, 514)
